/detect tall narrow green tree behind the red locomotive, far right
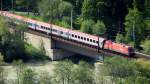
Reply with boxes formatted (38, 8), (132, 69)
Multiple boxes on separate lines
(125, 7), (144, 47)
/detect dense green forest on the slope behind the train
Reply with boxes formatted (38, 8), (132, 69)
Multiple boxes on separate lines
(1, 0), (150, 51)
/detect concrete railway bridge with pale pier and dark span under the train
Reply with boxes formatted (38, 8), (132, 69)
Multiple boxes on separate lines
(21, 30), (103, 60)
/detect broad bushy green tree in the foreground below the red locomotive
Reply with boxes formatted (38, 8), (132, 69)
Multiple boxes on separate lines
(107, 57), (137, 84)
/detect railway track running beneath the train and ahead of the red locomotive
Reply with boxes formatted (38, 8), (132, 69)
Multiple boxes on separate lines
(28, 30), (150, 60)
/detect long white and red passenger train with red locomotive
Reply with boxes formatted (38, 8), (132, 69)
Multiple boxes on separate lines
(0, 11), (135, 56)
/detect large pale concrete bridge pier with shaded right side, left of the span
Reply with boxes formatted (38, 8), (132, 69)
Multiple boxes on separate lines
(25, 32), (75, 60)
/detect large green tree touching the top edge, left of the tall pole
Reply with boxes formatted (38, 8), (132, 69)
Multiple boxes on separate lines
(38, 0), (61, 22)
